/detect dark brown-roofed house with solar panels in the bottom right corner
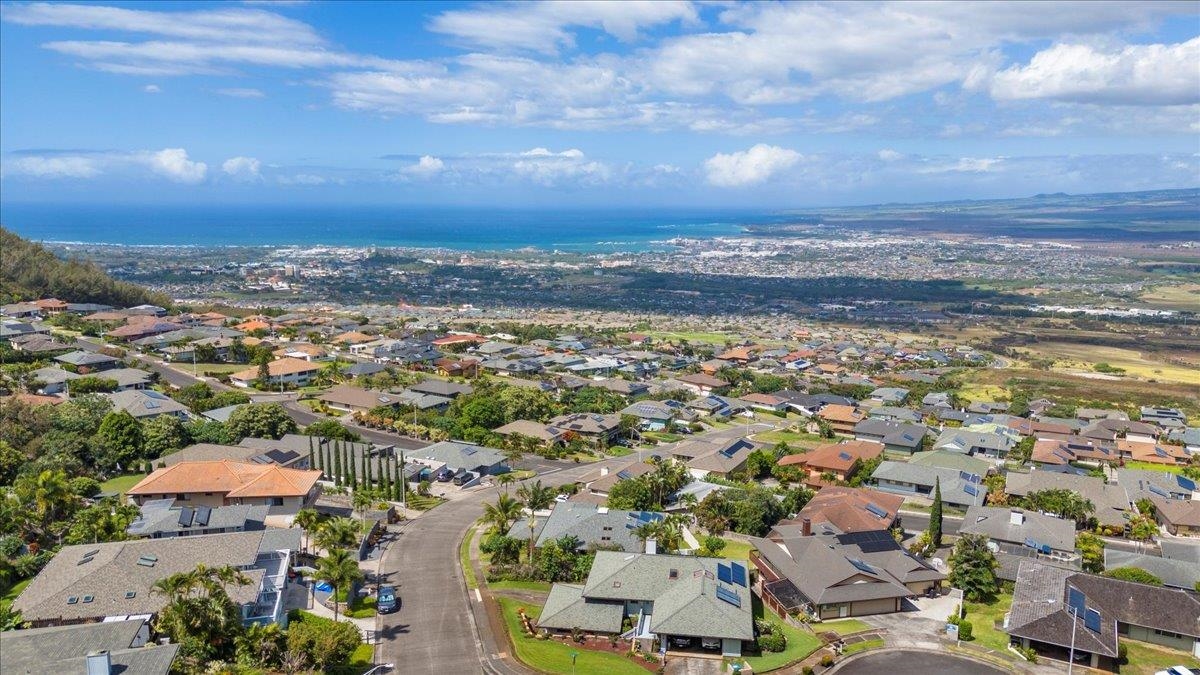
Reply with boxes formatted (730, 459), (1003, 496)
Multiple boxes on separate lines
(1004, 560), (1200, 670)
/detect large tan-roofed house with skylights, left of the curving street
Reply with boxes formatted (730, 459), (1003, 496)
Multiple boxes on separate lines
(12, 528), (300, 627)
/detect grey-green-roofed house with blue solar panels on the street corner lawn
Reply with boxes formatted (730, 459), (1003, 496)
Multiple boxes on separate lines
(538, 551), (755, 658)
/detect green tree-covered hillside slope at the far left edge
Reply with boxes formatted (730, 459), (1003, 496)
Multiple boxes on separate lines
(0, 227), (170, 306)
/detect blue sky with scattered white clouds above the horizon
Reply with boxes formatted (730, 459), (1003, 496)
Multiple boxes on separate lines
(0, 0), (1200, 208)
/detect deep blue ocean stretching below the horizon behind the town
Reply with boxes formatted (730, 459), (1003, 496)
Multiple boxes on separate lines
(0, 203), (787, 252)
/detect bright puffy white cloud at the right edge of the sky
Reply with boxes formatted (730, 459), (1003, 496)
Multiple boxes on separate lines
(991, 37), (1200, 106)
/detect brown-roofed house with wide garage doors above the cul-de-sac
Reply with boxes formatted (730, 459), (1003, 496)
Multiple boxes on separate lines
(750, 530), (946, 621)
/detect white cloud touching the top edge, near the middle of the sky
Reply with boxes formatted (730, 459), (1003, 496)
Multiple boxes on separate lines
(428, 0), (698, 53)
